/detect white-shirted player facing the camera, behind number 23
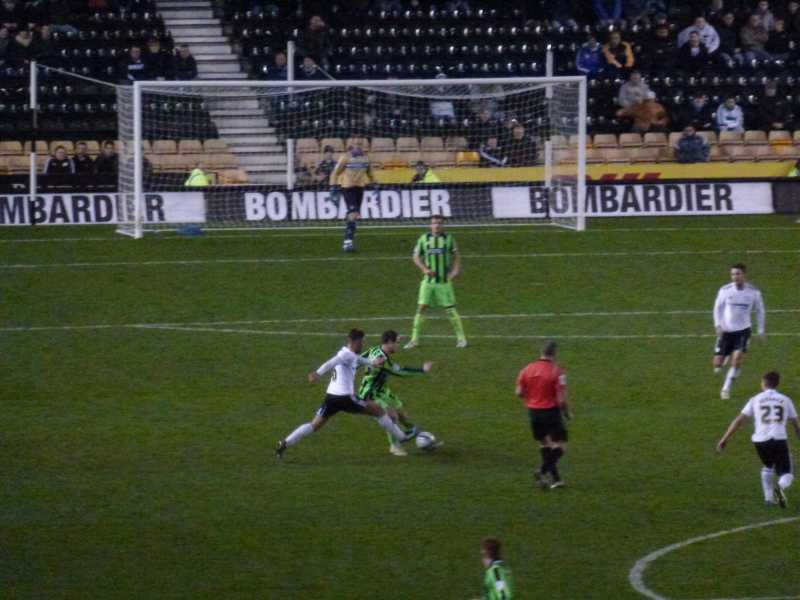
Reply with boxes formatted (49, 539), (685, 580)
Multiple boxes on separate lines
(714, 263), (765, 400)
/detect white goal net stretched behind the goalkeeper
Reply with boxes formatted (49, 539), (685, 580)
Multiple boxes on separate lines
(118, 77), (586, 237)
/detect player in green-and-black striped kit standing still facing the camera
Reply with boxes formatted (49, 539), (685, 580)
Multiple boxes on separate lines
(405, 216), (467, 350)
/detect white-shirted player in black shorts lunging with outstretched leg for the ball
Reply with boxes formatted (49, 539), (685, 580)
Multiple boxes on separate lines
(275, 329), (410, 458)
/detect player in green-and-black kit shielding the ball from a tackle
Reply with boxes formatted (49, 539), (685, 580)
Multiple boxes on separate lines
(358, 329), (433, 456)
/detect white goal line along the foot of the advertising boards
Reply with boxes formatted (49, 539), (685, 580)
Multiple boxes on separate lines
(0, 225), (800, 244)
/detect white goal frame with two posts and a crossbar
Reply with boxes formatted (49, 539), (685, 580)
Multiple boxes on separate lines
(117, 75), (587, 239)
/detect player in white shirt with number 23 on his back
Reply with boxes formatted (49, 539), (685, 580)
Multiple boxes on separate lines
(717, 371), (800, 508)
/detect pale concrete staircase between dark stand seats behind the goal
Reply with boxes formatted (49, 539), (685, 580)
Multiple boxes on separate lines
(157, 0), (286, 184)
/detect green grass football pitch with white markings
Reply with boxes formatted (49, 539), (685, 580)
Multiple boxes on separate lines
(0, 216), (800, 600)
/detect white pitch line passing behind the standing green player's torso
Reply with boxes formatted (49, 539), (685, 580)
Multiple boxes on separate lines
(0, 249), (800, 271)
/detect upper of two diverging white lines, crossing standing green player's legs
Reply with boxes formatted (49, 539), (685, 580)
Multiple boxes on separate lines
(0, 308), (800, 335)
